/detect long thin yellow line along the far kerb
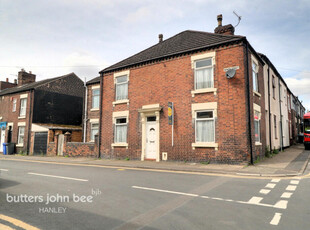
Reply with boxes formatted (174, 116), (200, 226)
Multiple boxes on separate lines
(0, 158), (310, 180)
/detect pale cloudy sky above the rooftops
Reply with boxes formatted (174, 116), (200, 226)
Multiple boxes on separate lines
(0, 0), (310, 109)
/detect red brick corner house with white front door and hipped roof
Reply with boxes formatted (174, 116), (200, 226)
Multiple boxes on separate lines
(99, 16), (266, 163)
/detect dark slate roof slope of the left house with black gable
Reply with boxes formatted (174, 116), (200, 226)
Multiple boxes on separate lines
(0, 73), (76, 96)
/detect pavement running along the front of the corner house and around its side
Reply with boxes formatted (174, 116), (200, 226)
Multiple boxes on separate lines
(0, 144), (310, 177)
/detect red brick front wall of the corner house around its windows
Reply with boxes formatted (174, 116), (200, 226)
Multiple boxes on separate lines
(101, 41), (264, 163)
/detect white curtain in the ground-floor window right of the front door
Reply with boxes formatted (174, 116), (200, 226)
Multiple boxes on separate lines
(196, 120), (214, 142)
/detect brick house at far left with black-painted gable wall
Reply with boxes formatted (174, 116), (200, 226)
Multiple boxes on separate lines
(0, 70), (83, 154)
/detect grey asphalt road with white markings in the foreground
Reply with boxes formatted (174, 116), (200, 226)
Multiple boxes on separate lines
(0, 160), (310, 230)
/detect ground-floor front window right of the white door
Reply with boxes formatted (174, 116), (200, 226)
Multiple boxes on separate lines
(195, 110), (215, 143)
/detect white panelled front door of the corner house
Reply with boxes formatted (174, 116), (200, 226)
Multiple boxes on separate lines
(145, 122), (157, 159)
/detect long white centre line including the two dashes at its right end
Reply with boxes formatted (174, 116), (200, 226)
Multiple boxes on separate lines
(131, 186), (287, 209)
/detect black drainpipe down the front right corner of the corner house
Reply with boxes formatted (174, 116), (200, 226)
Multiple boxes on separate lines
(245, 40), (254, 165)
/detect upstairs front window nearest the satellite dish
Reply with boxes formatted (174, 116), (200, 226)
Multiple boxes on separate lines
(194, 58), (214, 89)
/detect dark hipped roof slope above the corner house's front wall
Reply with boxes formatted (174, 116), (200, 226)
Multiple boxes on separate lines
(100, 30), (245, 73)
